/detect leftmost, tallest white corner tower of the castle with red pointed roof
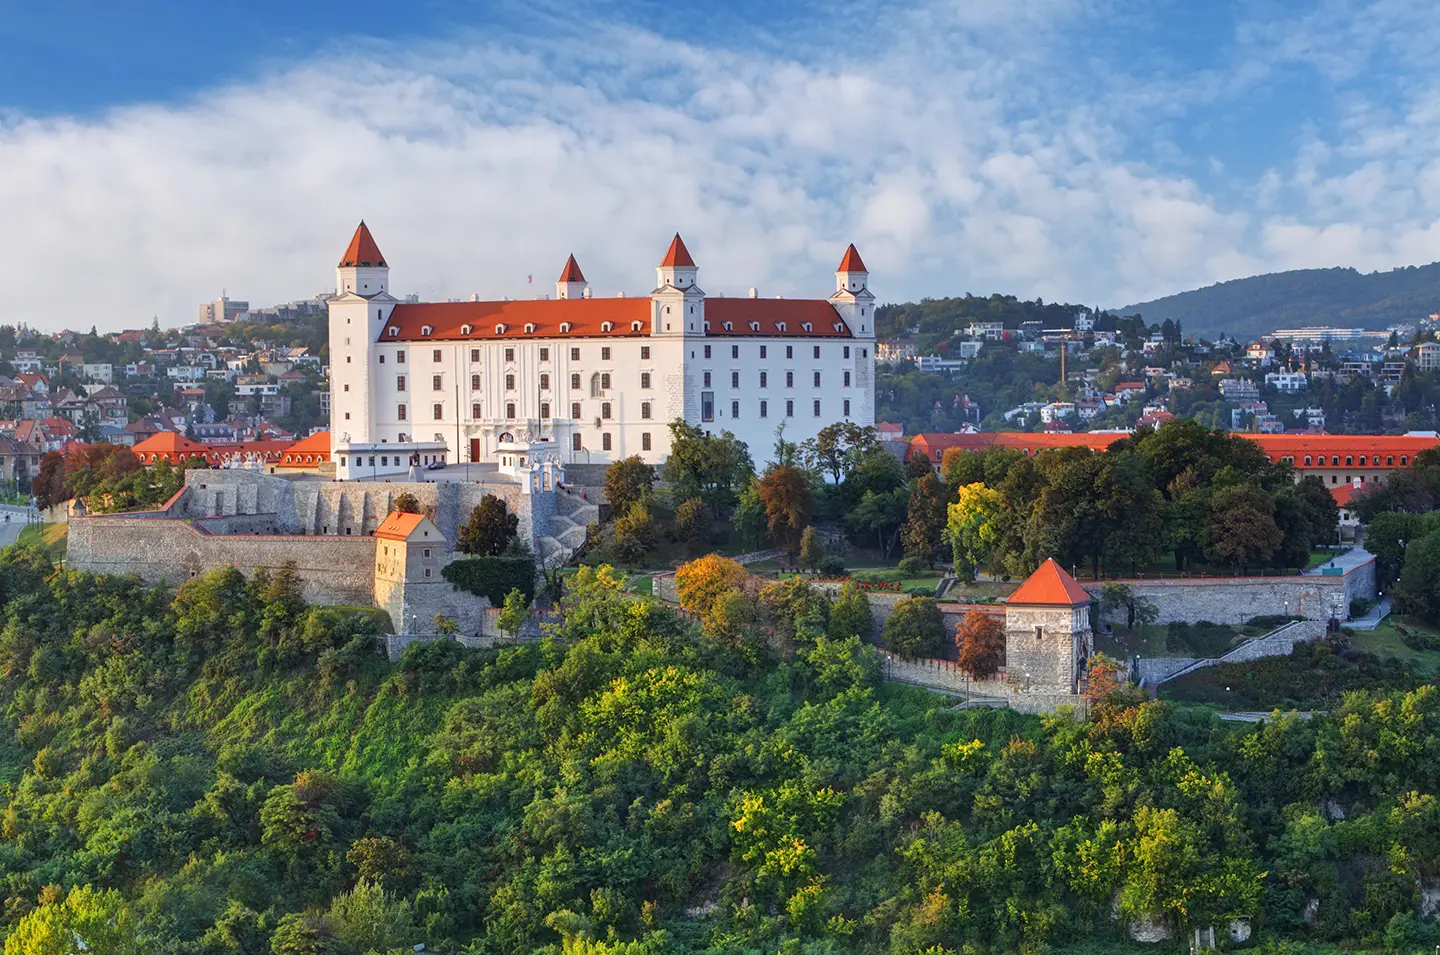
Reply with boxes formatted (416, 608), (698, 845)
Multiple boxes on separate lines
(330, 222), (396, 459)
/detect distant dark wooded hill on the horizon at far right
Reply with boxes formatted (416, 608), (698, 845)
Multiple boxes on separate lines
(1116, 262), (1440, 337)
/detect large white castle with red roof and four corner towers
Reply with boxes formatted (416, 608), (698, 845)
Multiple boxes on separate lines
(330, 222), (876, 480)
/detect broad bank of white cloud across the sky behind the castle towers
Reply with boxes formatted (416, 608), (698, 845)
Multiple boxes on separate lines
(0, 0), (1440, 328)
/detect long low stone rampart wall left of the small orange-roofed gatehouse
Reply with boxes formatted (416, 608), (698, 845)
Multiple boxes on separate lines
(66, 514), (374, 606)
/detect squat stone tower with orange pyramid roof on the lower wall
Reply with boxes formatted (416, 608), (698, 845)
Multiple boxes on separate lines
(1005, 557), (1094, 693)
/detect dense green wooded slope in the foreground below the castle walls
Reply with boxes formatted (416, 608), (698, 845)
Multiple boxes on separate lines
(0, 547), (1440, 955)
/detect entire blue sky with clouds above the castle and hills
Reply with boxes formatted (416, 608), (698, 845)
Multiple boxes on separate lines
(0, 0), (1440, 330)
